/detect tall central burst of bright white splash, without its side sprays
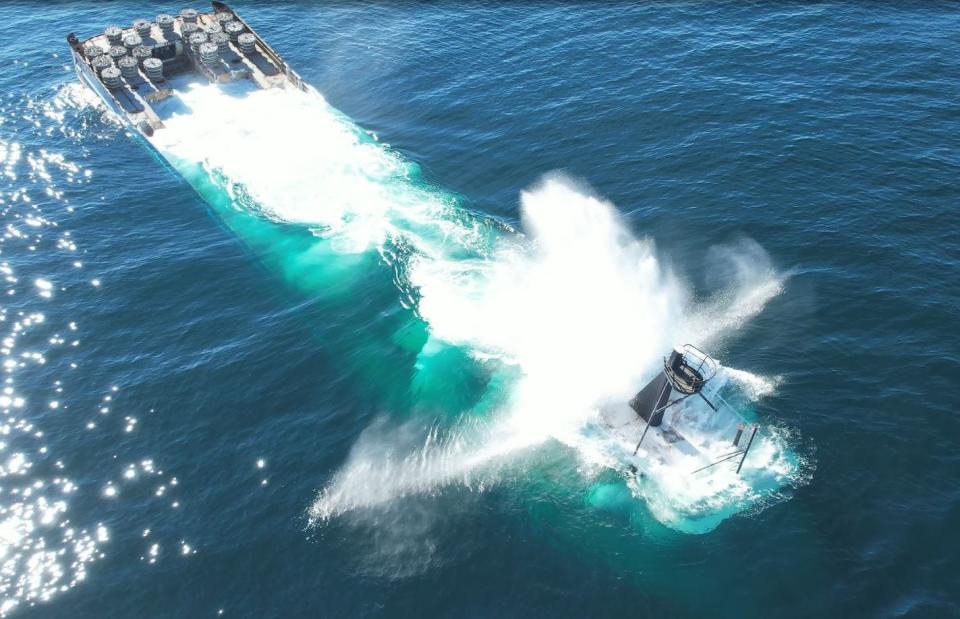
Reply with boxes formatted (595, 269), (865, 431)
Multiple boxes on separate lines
(411, 177), (686, 418)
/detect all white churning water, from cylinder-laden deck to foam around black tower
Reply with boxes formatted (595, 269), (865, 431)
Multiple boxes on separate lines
(144, 85), (800, 532)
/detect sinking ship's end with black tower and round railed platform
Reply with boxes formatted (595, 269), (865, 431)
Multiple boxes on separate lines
(600, 344), (760, 476)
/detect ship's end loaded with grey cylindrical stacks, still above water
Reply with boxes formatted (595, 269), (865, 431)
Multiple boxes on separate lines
(67, 2), (315, 169)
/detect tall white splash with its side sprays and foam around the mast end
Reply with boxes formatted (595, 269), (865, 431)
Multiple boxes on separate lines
(311, 176), (795, 532)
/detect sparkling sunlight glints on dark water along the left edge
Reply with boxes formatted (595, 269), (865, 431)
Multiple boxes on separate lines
(0, 83), (196, 616)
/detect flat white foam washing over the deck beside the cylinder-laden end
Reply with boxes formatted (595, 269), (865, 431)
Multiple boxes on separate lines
(154, 85), (476, 260)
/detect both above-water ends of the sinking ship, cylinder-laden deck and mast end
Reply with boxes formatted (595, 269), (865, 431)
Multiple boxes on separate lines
(67, 2), (782, 512)
